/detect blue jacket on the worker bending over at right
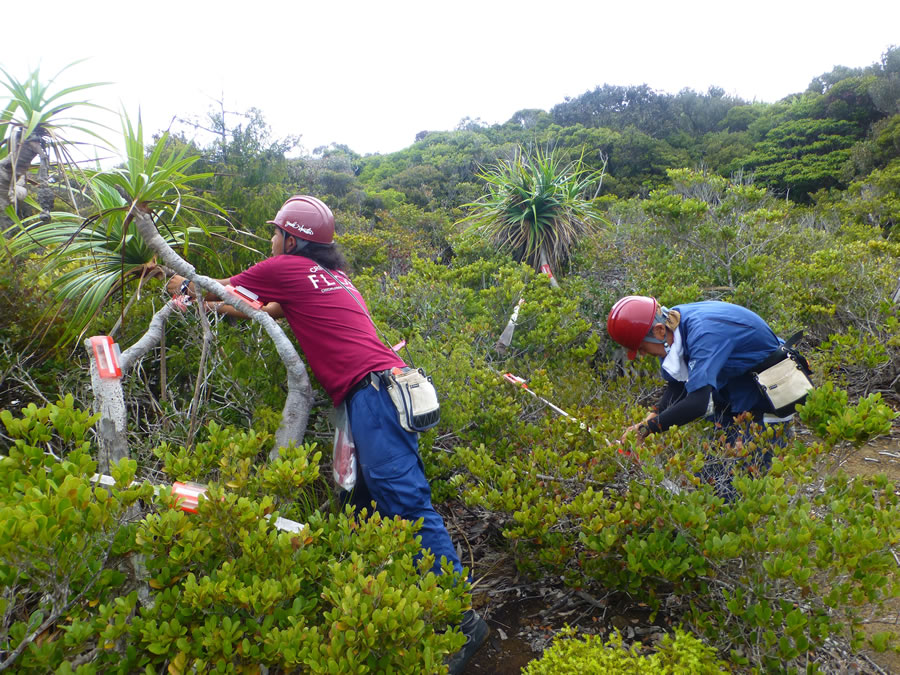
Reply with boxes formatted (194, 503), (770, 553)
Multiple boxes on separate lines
(663, 301), (783, 415)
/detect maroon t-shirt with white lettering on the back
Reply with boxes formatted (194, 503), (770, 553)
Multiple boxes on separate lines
(231, 255), (404, 405)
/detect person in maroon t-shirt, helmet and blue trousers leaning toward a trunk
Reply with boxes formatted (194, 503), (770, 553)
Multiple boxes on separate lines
(168, 195), (488, 673)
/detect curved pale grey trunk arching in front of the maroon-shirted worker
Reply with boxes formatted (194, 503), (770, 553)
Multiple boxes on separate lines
(133, 211), (312, 459)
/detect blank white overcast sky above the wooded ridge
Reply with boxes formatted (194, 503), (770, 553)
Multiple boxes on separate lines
(0, 0), (900, 158)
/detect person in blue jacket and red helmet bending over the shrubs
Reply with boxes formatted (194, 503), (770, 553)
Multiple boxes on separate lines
(607, 296), (791, 496)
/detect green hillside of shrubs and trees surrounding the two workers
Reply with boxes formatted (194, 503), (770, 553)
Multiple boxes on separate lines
(0, 48), (900, 674)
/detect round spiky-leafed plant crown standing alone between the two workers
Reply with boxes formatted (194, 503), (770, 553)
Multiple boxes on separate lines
(463, 148), (603, 270)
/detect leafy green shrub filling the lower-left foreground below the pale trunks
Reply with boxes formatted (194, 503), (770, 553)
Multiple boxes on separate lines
(0, 404), (468, 675)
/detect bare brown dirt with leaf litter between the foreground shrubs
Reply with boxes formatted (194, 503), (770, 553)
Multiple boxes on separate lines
(446, 429), (900, 675)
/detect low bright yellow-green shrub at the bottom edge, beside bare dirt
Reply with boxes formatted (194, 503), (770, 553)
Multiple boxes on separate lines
(522, 628), (731, 675)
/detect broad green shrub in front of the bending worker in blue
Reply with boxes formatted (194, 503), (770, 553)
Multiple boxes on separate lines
(453, 382), (900, 671)
